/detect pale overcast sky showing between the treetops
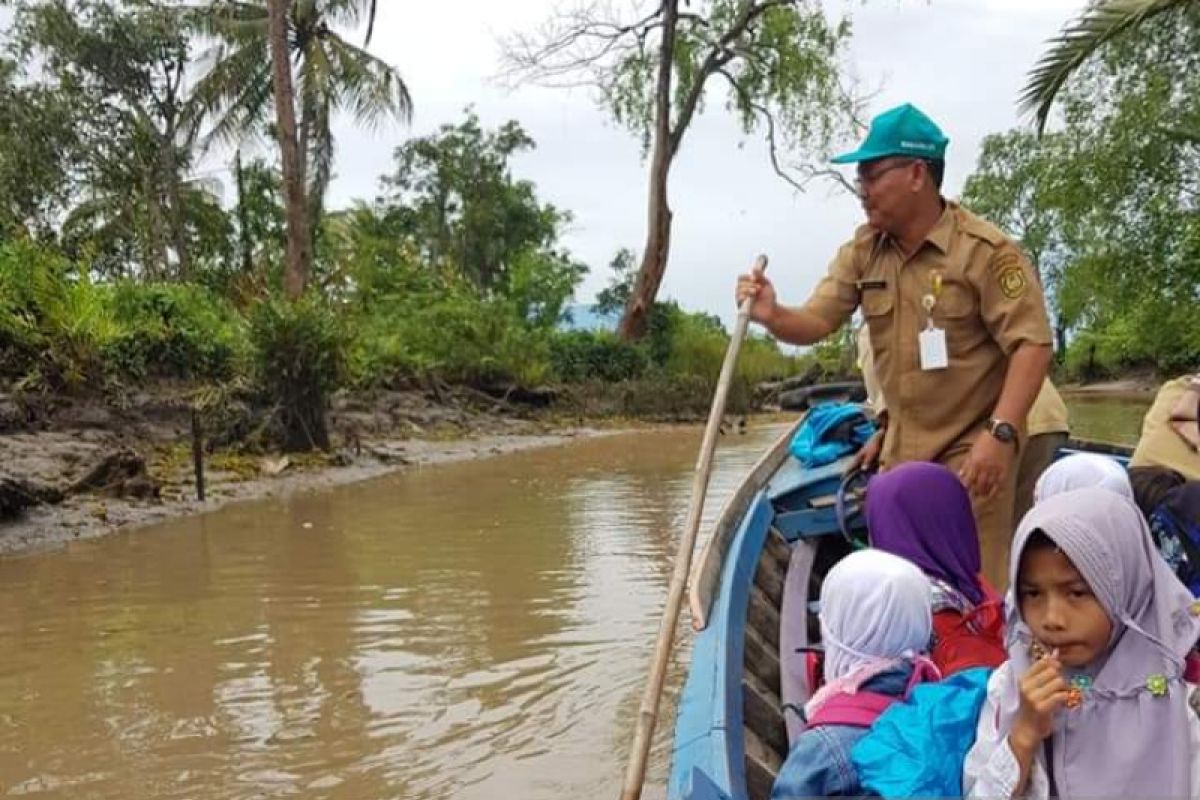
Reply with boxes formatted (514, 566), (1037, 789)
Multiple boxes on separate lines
(285, 0), (1086, 320)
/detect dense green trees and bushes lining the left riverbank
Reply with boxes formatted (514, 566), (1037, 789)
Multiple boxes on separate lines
(0, 0), (806, 429)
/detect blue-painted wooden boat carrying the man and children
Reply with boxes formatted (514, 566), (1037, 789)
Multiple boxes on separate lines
(667, 422), (1129, 800)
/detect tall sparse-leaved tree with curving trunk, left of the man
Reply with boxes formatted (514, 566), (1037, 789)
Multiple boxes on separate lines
(504, 0), (858, 339)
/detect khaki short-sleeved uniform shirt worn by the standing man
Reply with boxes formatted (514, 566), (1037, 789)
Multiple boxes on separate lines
(804, 203), (1051, 465)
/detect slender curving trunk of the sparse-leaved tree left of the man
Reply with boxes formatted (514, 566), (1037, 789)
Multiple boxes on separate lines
(618, 0), (679, 342)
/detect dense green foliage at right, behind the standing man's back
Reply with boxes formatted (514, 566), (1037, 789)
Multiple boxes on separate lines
(964, 4), (1200, 378)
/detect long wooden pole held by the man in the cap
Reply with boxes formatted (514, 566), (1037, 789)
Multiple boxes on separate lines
(620, 255), (767, 800)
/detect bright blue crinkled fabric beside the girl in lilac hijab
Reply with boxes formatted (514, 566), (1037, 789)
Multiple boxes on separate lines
(850, 667), (992, 798)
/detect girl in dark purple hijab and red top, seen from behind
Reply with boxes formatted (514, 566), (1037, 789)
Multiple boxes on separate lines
(866, 462), (1006, 675)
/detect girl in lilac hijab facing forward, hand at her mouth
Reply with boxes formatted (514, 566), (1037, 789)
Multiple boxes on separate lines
(964, 488), (1200, 800)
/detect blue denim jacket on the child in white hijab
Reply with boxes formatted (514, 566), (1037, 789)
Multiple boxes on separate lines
(770, 667), (912, 800)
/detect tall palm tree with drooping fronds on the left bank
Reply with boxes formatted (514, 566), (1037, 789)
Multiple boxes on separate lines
(190, 0), (412, 296)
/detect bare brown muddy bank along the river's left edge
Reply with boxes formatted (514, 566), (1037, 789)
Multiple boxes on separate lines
(0, 391), (636, 554)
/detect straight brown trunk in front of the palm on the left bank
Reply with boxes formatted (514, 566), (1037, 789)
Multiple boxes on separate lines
(266, 0), (312, 300)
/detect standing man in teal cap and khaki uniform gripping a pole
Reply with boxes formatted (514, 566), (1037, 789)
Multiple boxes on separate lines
(737, 104), (1052, 587)
